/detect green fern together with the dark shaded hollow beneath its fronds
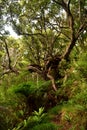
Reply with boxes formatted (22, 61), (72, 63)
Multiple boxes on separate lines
(10, 80), (50, 113)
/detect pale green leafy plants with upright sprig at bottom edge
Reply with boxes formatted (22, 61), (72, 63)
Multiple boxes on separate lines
(13, 107), (57, 130)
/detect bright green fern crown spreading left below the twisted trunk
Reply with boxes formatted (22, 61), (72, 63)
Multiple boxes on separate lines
(13, 81), (50, 96)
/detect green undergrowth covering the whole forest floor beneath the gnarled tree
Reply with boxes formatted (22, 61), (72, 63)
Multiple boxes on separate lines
(0, 49), (87, 130)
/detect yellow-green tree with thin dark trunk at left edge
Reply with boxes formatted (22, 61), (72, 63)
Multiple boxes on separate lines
(0, 36), (25, 76)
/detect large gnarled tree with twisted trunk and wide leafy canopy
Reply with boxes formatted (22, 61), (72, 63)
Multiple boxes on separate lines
(0, 0), (87, 91)
